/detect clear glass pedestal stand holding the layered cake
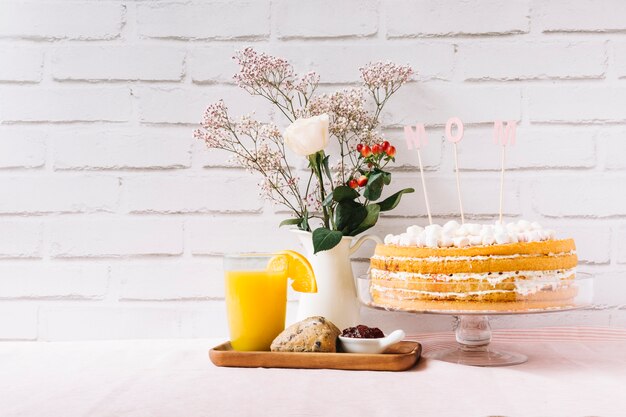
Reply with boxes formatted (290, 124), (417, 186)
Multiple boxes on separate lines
(356, 272), (593, 366)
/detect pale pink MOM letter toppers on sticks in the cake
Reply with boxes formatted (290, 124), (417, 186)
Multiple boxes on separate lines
(404, 117), (517, 224)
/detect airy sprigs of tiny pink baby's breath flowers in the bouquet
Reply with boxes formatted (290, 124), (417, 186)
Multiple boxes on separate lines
(194, 48), (413, 228)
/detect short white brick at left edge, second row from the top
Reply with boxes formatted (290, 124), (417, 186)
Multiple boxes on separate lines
(0, 47), (43, 83)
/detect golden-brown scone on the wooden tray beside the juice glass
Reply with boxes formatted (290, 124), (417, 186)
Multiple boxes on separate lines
(270, 316), (341, 352)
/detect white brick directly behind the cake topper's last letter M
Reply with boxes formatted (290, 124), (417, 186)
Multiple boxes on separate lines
(458, 126), (596, 171)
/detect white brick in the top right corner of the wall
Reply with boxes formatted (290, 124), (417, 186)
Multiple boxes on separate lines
(536, 0), (626, 32)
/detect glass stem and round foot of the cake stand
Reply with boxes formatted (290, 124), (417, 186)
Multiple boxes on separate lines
(424, 314), (528, 366)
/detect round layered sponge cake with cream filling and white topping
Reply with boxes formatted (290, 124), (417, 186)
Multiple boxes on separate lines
(370, 220), (578, 311)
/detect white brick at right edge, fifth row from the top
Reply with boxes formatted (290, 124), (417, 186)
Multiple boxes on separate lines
(532, 175), (626, 217)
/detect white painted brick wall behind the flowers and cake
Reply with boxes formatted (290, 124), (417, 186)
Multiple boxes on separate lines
(0, 0), (626, 340)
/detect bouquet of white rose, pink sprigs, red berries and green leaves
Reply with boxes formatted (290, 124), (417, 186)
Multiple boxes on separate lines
(194, 48), (414, 253)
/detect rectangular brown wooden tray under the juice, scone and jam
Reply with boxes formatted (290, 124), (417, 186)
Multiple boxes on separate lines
(209, 341), (422, 371)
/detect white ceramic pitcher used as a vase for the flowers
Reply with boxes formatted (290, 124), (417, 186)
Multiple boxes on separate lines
(293, 230), (382, 330)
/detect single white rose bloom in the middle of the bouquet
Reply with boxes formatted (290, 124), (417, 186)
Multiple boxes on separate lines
(283, 114), (328, 156)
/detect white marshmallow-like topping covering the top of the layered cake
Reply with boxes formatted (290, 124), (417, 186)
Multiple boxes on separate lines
(385, 220), (556, 248)
